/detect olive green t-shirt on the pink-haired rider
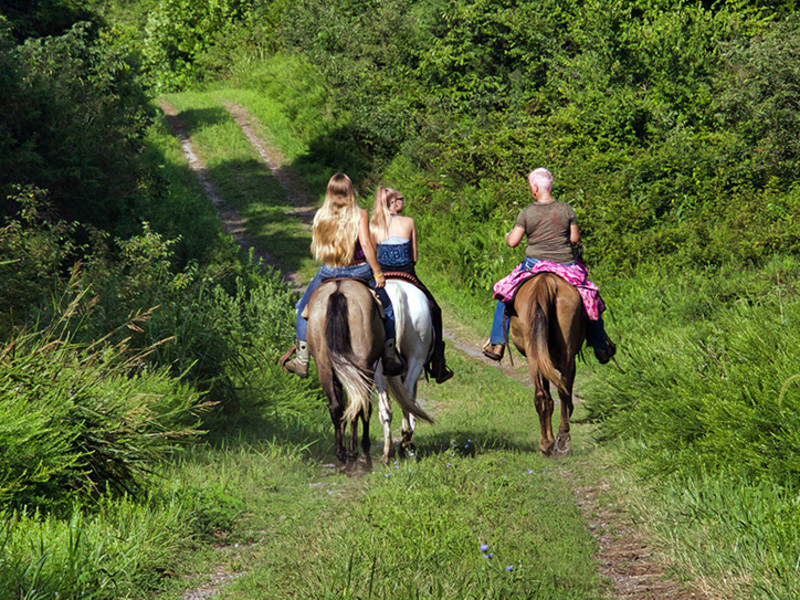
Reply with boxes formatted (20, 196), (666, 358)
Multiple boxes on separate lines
(516, 200), (578, 264)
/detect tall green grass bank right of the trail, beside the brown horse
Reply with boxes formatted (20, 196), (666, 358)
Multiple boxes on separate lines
(582, 258), (800, 599)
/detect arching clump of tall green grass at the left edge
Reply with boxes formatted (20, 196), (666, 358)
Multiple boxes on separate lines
(0, 289), (203, 509)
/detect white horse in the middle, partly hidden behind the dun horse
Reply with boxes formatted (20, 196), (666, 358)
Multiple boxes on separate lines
(375, 279), (434, 463)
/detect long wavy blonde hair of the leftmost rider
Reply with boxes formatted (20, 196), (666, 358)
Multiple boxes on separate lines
(311, 173), (361, 267)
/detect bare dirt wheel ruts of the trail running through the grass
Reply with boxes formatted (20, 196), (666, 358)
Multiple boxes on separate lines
(159, 100), (711, 600)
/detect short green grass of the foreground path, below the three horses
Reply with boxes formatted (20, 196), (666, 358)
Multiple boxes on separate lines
(162, 355), (607, 599)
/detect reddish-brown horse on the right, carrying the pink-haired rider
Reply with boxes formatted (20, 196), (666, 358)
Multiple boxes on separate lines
(509, 273), (585, 456)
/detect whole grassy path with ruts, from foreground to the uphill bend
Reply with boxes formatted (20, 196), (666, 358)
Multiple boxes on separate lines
(153, 92), (703, 600)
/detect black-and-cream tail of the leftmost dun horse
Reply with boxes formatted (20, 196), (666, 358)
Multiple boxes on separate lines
(325, 287), (373, 421)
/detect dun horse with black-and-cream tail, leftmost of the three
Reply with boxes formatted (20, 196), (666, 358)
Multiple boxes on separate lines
(308, 279), (427, 474)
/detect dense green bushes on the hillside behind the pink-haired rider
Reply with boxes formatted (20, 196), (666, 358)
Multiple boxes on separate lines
(205, 0), (798, 276)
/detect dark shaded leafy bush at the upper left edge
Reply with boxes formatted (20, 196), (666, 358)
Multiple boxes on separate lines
(0, 18), (148, 228)
